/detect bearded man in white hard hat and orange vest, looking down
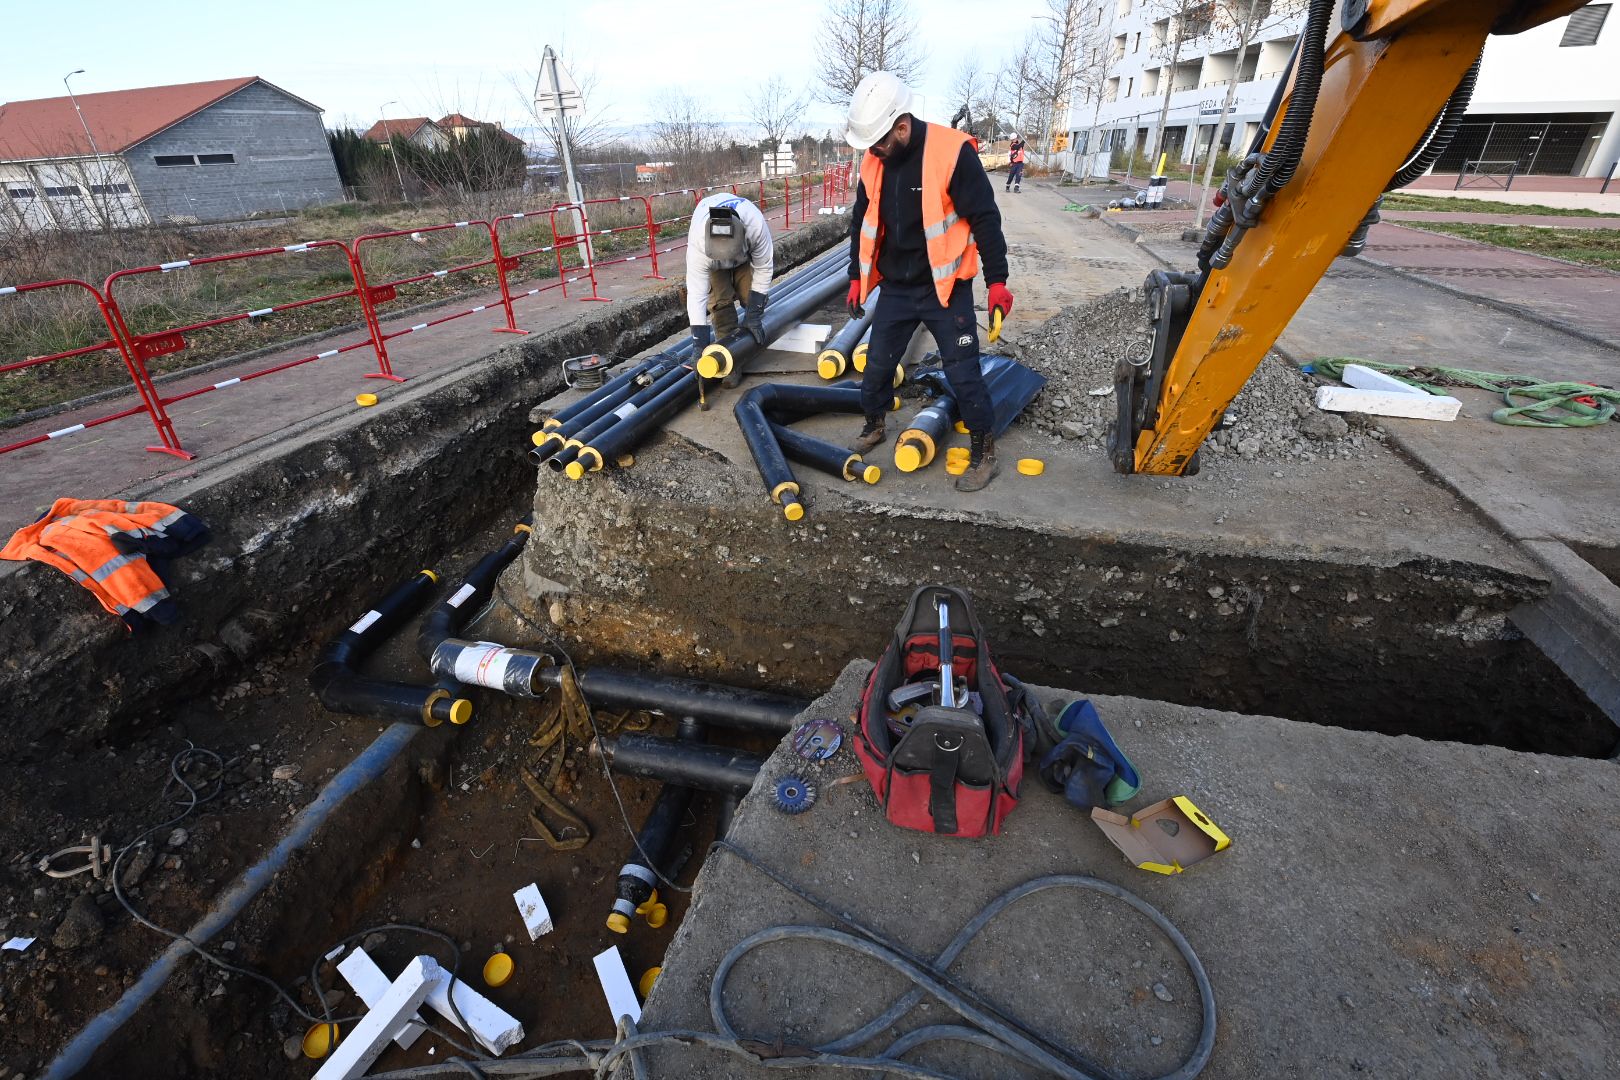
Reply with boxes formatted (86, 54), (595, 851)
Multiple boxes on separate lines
(844, 71), (1013, 491)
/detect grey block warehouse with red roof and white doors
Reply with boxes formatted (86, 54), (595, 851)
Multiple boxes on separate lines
(0, 76), (343, 233)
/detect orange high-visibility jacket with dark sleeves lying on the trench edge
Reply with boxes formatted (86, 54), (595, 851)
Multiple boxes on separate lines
(0, 499), (207, 628)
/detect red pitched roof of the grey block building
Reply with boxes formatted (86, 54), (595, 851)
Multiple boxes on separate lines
(0, 74), (316, 160)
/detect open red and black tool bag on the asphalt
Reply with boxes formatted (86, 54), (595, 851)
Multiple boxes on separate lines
(855, 585), (1024, 836)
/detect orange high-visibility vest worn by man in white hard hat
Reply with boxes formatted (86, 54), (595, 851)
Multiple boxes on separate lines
(860, 121), (978, 306)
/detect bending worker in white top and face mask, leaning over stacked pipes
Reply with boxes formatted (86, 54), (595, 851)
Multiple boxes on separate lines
(687, 191), (776, 387)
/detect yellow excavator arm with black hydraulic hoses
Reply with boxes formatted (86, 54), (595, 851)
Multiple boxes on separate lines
(1110, 0), (1586, 476)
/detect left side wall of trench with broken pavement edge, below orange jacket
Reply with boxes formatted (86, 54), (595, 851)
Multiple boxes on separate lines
(0, 219), (846, 759)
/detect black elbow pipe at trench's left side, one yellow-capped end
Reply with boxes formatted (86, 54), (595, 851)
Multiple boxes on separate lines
(309, 570), (473, 727)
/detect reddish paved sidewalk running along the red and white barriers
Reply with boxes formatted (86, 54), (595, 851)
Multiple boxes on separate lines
(0, 205), (821, 533)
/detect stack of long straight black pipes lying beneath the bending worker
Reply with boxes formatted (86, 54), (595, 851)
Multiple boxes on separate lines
(530, 249), (847, 479)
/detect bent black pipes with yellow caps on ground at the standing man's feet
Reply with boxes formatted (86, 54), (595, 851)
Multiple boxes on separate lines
(732, 382), (899, 521)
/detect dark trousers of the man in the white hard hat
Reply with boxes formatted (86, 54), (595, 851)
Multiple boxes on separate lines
(860, 282), (993, 432)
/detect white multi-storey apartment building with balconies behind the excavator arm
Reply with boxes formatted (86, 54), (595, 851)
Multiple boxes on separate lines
(1066, 0), (1620, 176)
